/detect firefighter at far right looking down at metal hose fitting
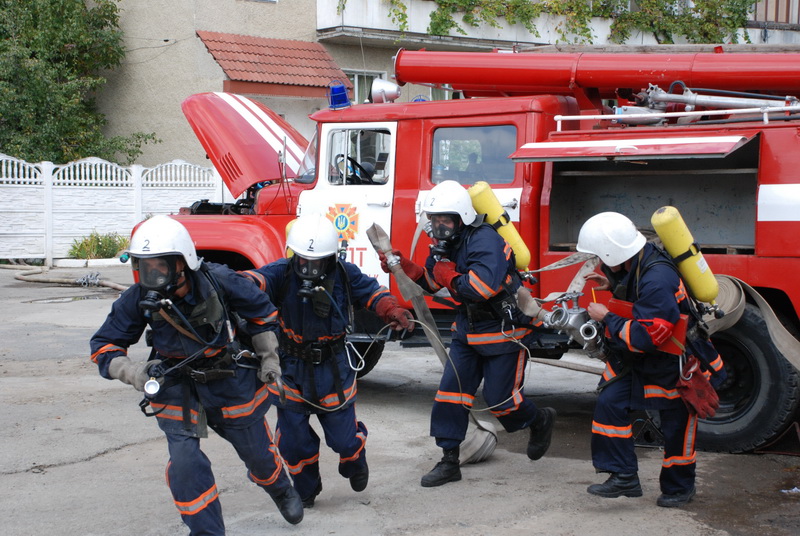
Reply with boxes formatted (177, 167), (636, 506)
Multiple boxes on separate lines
(577, 212), (725, 507)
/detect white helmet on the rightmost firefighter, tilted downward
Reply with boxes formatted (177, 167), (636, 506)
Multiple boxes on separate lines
(576, 212), (647, 266)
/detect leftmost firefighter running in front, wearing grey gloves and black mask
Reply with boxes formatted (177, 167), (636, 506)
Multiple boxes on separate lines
(90, 216), (303, 535)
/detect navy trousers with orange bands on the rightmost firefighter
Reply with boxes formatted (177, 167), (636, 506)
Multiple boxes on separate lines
(592, 374), (697, 495)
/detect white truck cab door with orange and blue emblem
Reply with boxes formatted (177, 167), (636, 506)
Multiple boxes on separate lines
(298, 122), (397, 288)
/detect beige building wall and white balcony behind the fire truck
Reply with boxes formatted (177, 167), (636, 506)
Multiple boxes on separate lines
(98, 0), (800, 166)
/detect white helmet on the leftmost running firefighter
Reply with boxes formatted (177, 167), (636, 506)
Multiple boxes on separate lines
(128, 216), (200, 271)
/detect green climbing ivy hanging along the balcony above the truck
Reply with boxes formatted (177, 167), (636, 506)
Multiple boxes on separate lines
(337, 0), (758, 44)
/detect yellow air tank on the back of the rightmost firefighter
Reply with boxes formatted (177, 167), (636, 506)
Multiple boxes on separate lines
(650, 206), (719, 305)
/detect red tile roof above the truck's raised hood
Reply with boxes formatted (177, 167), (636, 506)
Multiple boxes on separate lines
(197, 30), (352, 94)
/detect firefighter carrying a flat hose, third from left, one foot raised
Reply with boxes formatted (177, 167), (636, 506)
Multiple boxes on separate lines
(382, 181), (556, 487)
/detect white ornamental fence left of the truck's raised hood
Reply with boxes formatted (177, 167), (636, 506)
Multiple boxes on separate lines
(0, 155), (232, 266)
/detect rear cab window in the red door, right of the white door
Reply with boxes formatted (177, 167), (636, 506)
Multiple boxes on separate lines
(431, 125), (517, 184)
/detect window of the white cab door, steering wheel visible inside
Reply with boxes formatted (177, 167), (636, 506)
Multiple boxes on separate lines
(328, 128), (391, 184)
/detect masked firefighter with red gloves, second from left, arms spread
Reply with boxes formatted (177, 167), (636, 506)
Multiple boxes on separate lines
(244, 214), (413, 508)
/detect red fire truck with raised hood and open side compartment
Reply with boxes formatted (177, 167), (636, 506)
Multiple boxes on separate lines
(172, 50), (800, 452)
